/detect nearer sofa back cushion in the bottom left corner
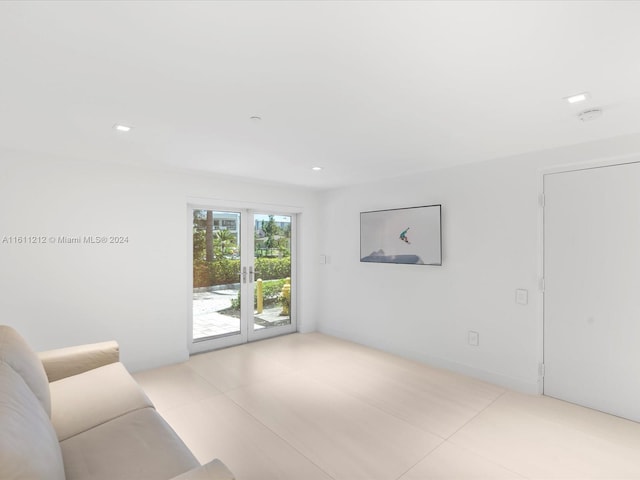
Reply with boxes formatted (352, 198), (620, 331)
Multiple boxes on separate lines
(0, 361), (65, 480)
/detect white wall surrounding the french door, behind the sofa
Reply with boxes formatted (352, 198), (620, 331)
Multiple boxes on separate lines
(0, 151), (318, 370)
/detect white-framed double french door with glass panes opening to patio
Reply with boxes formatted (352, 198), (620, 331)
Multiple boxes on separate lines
(189, 206), (296, 353)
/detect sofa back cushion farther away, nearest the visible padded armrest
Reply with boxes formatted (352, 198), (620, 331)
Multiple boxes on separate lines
(0, 325), (51, 418)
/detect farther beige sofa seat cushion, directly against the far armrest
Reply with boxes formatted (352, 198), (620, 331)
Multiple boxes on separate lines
(50, 363), (153, 441)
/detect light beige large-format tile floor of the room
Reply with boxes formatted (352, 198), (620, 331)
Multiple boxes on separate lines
(135, 334), (640, 480)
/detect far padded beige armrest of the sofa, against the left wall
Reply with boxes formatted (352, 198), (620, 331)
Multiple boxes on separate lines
(38, 341), (120, 382)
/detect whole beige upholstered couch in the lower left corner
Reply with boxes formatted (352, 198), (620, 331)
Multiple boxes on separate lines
(0, 325), (233, 480)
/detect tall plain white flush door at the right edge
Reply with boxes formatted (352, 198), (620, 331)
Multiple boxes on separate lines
(544, 163), (640, 421)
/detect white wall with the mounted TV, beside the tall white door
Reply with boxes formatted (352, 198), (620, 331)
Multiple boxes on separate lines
(318, 135), (640, 393)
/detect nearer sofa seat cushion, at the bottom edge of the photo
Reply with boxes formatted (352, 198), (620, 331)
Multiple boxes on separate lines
(60, 408), (200, 480)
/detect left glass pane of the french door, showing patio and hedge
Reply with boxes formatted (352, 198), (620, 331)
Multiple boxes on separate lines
(193, 209), (242, 342)
